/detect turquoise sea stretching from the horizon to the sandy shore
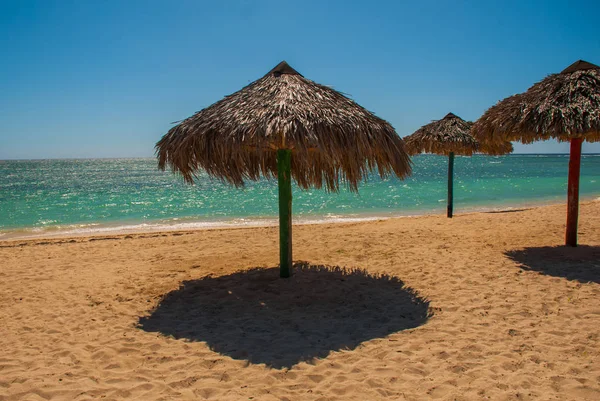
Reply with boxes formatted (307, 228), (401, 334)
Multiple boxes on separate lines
(0, 154), (600, 239)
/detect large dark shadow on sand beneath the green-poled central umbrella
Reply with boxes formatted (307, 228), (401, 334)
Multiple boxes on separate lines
(139, 262), (430, 369)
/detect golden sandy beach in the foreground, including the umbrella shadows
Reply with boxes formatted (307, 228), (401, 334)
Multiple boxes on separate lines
(0, 201), (600, 401)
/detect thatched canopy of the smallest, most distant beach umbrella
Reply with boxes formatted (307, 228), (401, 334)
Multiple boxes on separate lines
(404, 113), (478, 156)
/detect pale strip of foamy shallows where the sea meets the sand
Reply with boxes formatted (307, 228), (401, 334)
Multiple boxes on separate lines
(0, 195), (600, 244)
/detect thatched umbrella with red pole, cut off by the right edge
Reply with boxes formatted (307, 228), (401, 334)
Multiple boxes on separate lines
(472, 60), (600, 246)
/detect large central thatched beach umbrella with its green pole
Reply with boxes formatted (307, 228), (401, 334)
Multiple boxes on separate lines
(156, 61), (411, 277)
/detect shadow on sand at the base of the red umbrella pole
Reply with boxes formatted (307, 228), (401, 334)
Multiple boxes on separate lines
(505, 245), (600, 283)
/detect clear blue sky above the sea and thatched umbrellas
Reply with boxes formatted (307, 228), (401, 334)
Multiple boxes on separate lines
(0, 0), (600, 159)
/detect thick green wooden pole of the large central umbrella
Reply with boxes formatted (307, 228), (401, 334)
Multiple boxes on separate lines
(277, 149), (292, 278)
